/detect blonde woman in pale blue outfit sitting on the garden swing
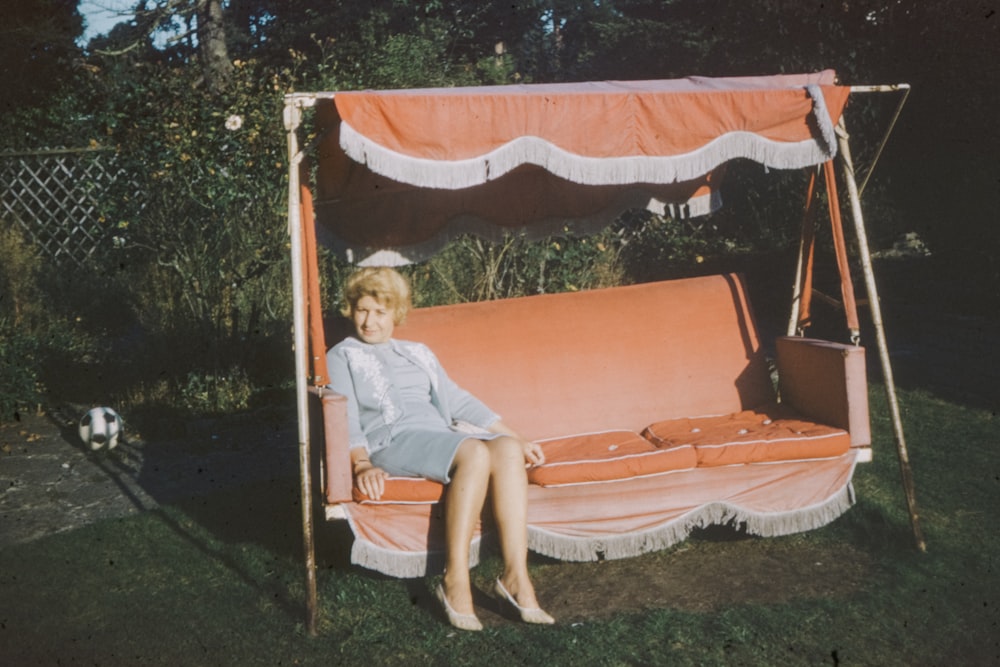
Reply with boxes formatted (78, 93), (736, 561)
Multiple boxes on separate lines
(327, 268), (554, 630)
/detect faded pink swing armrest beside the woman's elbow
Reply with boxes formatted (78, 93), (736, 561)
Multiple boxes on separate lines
(309, 387), (354, 505)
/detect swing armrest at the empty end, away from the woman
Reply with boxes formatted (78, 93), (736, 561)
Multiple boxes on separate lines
(776, 336), (871, 447)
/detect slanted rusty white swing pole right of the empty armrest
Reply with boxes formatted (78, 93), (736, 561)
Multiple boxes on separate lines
(836, 116), (927, 551)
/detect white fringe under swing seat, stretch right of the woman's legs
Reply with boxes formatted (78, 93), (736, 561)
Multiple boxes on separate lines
(528, 482), (854, 562)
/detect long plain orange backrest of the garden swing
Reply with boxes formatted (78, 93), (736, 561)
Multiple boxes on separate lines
(382, 274), (774, 439)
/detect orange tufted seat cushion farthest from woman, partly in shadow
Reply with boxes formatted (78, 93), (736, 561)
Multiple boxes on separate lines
(642, 406), (851, 467)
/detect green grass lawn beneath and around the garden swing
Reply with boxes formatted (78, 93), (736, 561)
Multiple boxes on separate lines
(0, 387), (1000, 666)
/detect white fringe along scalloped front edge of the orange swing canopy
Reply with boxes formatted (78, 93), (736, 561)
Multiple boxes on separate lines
(340, 118), (836, 190)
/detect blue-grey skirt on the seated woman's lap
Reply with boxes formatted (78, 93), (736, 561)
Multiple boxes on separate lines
(371, 428), (500, 484)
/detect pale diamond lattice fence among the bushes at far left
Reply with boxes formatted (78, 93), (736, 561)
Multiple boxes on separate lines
(0, 148), (139, 266)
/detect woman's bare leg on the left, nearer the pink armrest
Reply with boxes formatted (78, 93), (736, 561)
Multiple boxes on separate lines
(443, 439), (492, 614)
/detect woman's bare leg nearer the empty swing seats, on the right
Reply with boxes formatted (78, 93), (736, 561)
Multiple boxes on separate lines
(486, 436), (538, 608)
